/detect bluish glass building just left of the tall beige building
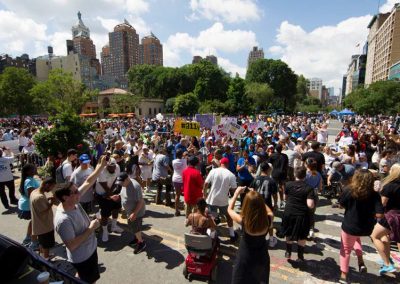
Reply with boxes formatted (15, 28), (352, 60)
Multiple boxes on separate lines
(345, 54), (367, 96)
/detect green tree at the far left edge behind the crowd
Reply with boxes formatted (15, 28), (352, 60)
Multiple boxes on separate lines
(0, 67), (39, 116)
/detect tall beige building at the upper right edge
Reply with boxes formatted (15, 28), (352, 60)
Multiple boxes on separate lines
(365, 4), (400, 85)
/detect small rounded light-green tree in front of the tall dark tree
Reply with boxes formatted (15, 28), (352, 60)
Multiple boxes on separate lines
(245, 83), (274, 112)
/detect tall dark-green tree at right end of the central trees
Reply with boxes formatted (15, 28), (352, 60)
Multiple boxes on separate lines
(246, 59), (297, 110)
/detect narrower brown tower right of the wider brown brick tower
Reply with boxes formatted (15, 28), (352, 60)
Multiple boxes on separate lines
(139, 33), (163, 66)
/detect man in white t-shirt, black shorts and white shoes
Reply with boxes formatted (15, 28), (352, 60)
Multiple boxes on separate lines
(96, 158), (124, 242)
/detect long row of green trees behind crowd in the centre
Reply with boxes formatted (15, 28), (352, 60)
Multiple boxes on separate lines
(128, 59), (312, 115)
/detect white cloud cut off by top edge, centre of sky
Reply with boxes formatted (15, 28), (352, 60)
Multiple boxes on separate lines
(188, 0), (261, 23)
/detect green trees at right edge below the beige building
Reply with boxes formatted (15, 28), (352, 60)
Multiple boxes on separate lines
(344, 81), (400, 115)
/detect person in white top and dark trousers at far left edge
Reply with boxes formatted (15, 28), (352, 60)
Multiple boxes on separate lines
(0, 148), (18, 209)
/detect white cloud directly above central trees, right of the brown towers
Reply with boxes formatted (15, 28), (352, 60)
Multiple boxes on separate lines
(164, 23), (258, 75)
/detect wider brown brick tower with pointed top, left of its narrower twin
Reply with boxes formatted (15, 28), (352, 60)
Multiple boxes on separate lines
(102, 20), (139, 81)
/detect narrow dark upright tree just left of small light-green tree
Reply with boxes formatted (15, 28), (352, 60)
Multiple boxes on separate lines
(226, 75), (249, 115)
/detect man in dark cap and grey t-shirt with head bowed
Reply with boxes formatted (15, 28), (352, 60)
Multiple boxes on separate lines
(116, 172), (146, 254)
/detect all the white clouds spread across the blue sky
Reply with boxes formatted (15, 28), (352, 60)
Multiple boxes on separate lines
(0, 0), (399, 88)
